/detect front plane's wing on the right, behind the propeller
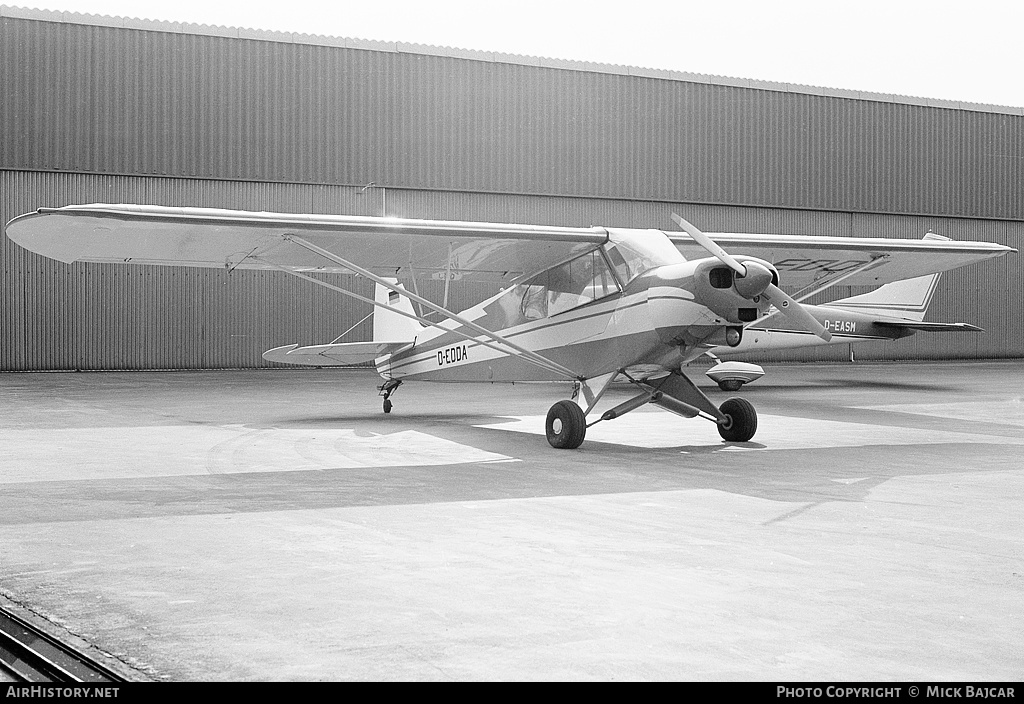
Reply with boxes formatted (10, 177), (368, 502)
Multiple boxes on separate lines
(666, 232), (1017, 291)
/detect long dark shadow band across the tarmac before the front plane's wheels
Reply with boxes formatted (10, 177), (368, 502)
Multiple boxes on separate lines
(0, 427), (1016, 525)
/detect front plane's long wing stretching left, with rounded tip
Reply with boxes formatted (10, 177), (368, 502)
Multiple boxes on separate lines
(6, 204), (607, 280)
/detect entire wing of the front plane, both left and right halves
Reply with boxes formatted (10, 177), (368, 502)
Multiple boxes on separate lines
(7, 204), (1015, 291)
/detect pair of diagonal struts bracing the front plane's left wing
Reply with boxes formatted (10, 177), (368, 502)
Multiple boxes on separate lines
(261, 234), (581, 381)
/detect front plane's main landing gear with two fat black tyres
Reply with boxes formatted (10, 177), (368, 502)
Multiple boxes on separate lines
(545, 372), (758, 449)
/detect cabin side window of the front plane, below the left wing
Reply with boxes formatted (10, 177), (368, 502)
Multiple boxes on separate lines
(517, 250), (618, 320)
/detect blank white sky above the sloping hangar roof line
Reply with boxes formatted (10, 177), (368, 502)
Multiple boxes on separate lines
(6, 0), (1024, 106)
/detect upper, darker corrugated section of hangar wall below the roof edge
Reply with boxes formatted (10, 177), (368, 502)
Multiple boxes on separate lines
(0, 17), (1024, 220)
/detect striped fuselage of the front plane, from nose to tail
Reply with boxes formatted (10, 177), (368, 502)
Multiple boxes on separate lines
(377, 259), (768, 382)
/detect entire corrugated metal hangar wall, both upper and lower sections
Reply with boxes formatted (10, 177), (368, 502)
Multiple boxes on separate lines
(0, 7), (1024, 370)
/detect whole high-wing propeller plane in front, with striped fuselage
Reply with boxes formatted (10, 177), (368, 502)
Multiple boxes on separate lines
(6, 205), (1014, 448)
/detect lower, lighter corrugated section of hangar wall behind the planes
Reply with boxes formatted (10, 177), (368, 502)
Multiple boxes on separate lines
(0, 171), (1024, 370)
